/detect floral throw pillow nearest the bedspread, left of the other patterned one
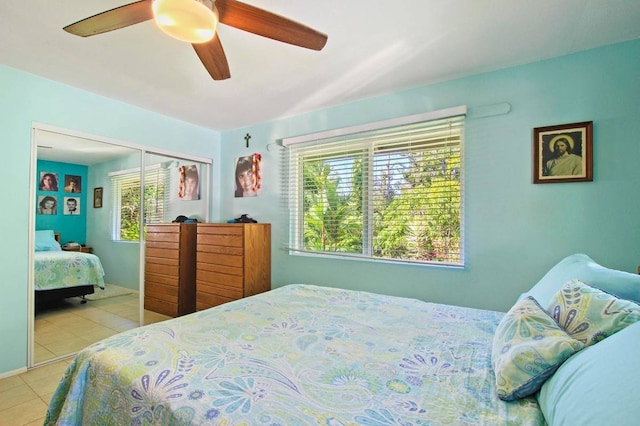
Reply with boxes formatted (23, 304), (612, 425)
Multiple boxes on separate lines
(491, 296), (584, 401)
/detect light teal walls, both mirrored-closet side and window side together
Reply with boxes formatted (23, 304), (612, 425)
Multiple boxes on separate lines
(0, 40), (640, 374)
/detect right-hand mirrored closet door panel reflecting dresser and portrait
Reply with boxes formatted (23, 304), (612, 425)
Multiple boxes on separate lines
(144, 153), (209, 317)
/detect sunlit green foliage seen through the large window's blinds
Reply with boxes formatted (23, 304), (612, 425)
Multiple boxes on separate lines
(302, 145), (461, 263)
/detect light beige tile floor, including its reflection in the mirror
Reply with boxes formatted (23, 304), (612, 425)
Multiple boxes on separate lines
(0, 294), (169, 426)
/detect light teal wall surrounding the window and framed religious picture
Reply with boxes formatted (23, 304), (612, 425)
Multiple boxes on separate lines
(221, 40), (640, 311)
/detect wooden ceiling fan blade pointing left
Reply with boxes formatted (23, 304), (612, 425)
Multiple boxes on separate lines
(63, 0), (153, 37)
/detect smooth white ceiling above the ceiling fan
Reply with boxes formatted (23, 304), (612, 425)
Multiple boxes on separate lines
(0, 0), (640, 130)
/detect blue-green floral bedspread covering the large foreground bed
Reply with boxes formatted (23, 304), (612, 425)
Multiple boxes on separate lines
(45, 284), (544, 426)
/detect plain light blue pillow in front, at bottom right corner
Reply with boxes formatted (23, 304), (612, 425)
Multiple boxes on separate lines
(537, 323), (640, 426)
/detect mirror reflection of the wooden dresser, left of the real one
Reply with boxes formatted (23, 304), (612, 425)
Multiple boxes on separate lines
(144, 223), (196, 317)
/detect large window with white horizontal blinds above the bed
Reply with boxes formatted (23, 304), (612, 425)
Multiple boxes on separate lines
(284, 115), (464, 265)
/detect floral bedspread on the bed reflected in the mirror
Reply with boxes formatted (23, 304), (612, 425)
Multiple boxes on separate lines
(34, 251), (104, 291)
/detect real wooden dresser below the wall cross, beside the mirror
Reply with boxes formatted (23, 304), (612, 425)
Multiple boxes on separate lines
(196, 223), (271, 311)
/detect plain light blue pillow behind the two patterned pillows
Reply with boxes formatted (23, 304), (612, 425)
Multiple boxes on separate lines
(523, 253), (640, 306)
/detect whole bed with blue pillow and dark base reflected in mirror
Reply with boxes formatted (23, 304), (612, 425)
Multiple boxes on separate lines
(34, 230), (105, 305)
